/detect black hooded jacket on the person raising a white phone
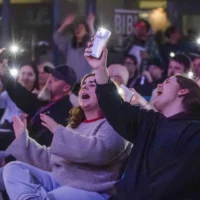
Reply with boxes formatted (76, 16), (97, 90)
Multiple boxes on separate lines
(96, 82), (200, 200)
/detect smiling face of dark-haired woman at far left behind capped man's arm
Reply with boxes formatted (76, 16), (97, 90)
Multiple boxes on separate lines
(18, 65), (36, 91)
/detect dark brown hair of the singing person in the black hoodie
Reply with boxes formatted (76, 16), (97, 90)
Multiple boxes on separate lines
(176, 75), (200, 117)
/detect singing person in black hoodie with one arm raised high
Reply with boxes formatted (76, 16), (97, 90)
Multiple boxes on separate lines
(85, 43), (200, 200)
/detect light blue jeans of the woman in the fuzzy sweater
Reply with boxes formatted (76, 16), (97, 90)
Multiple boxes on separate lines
(0, 161), (110, 200)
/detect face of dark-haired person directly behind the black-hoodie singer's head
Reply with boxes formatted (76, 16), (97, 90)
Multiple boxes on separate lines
(167, 59), (184, 77)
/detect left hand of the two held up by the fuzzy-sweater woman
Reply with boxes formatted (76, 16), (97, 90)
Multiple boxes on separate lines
(13, 116), (27, 138)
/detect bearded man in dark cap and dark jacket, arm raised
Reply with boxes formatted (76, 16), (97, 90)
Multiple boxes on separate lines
(0, 65), (76, 146)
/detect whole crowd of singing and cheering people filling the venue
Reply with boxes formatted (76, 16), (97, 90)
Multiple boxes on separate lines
(0, 11), (200, 200)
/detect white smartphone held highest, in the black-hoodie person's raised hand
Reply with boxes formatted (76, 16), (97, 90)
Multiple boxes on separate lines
(90, 28), (111, 58)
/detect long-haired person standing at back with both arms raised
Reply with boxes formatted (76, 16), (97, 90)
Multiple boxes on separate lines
(53, 14), (95, 82)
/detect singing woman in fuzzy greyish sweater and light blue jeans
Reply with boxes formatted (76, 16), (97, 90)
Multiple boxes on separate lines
(3, 74), (132, 200)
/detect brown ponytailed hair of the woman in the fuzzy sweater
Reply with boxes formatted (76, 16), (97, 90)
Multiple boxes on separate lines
(68, 73), (95, 128)
